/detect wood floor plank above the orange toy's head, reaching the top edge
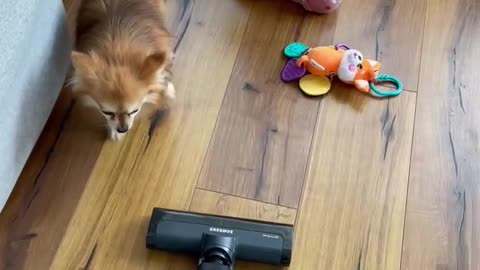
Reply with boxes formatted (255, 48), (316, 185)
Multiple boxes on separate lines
(335, 0), (426, 91)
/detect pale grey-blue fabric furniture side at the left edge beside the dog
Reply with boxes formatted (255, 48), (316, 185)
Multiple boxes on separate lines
(0, 0), (70, 211)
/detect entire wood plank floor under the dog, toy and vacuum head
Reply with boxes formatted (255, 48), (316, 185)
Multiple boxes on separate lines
(0, 0), (480, 270)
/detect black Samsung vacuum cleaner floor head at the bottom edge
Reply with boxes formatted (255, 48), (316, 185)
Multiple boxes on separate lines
(147, 208), (293, 270)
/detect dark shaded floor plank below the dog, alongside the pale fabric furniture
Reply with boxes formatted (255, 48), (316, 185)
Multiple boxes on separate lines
(1, 96), (104, 269)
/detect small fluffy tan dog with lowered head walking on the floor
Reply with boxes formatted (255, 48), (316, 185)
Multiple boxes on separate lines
(67, 0), (175, 140)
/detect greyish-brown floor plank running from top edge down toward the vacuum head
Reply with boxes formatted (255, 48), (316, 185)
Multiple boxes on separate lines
(198, 1), (335, 208)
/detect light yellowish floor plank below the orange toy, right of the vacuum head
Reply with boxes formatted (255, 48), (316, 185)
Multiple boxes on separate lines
(291, 87), (415, 270)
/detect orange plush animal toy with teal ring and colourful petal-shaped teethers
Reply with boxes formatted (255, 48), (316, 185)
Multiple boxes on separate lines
(282, 43), (402, 97)
